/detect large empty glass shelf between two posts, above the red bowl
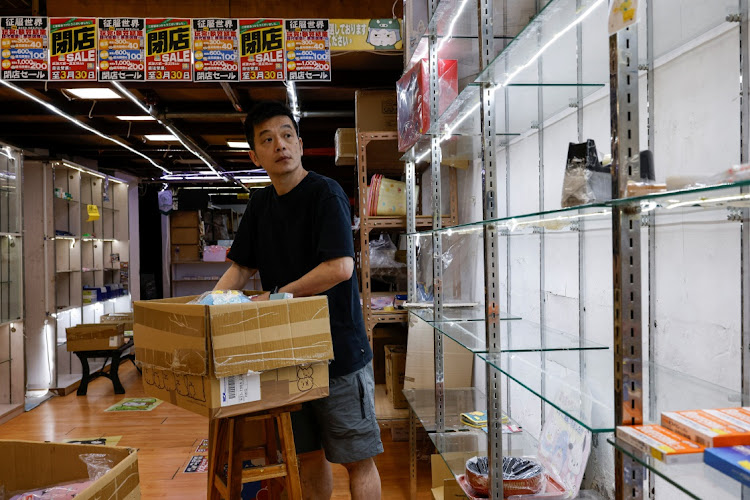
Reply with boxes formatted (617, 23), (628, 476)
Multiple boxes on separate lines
(479, 350), (614, 433)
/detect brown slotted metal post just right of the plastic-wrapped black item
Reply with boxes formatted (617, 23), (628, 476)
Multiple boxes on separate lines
(609, 24), (646, 500)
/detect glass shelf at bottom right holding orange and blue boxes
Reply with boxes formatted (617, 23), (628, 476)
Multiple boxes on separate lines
(607, 438), (742, 500)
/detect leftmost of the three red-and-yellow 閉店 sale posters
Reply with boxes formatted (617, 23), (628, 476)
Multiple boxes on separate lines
(49, 17), (97, 81)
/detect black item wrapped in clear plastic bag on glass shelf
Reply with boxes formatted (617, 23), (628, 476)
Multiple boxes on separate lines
(561, 139), (612, 207)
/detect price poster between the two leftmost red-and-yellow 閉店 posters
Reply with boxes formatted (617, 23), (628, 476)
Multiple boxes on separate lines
(99, 17), (146, 81)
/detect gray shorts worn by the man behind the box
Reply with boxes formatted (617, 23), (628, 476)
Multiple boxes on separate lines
(292, 364), (383, 464)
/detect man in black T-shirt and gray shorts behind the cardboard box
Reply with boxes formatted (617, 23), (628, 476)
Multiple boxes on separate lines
(215, 102), (383, 500)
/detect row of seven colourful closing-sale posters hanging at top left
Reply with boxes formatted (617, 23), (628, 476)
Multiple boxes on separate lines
(0, 16), (340, 82)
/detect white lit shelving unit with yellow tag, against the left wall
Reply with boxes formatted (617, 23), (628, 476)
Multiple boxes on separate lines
(24, 161), (132, 394)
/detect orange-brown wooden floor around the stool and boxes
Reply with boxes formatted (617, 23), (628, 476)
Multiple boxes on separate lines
(0, 363), (432, 500)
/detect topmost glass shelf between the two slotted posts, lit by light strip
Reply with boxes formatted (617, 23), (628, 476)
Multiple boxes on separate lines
(477, 0), (608, 86)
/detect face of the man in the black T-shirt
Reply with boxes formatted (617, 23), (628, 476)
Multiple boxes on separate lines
(250, 115), (302, 175)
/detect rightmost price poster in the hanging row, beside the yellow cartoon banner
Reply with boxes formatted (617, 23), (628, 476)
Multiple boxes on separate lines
(284, 19), (331, 81)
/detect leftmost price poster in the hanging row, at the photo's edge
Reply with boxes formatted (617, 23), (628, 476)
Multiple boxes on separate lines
(0, 17), (49, 80)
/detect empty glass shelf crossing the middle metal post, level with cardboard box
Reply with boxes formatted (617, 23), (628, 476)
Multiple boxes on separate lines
(411, 310), (608, 353)
